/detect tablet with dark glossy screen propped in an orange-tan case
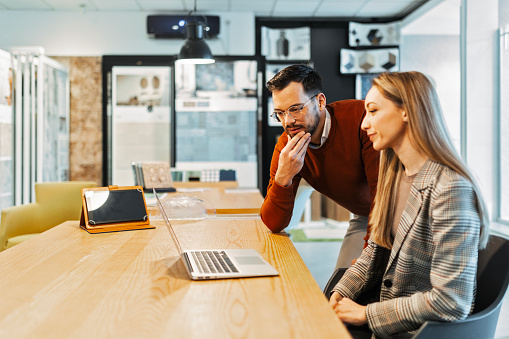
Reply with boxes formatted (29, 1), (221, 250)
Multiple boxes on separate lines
(85, 189), (148, 226)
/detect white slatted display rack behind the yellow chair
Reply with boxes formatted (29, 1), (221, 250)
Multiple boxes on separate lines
(10, 47), (70, 205)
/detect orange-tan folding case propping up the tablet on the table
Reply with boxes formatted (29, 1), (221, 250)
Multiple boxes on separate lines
(80, 186), (155, 233)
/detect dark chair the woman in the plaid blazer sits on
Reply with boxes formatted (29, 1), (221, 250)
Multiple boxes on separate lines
(324, 235), (509, 339)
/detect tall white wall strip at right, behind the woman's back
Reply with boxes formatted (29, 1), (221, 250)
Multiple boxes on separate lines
(465, 0), (498, 216)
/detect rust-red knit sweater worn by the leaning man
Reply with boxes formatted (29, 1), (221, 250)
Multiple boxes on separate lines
(260, 100), (379, 244)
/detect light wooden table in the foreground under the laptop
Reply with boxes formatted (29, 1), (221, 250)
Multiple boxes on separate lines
(0, 219), (350, 339)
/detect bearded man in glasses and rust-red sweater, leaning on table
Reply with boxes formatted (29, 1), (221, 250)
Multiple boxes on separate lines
(260, 65), (379, 268)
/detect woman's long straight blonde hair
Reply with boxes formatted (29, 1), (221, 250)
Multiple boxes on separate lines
(369, 72), (489, 249)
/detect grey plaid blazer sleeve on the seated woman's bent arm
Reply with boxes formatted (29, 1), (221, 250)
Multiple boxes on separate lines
(366, 178), (480, 337)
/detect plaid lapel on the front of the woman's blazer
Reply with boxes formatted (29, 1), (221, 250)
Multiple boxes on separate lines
(386, 159), (437, 272)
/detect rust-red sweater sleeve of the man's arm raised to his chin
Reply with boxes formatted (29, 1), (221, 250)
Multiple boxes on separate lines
(260, 133), (301, 232)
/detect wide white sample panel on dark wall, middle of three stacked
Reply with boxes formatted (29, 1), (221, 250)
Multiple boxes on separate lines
(340, 48), (399, 74)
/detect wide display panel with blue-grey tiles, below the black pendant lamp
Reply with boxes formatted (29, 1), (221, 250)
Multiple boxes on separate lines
(175, 60), (258, 187)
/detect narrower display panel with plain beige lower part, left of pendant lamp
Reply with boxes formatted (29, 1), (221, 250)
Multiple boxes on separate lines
(108, 66), (172, 186)
